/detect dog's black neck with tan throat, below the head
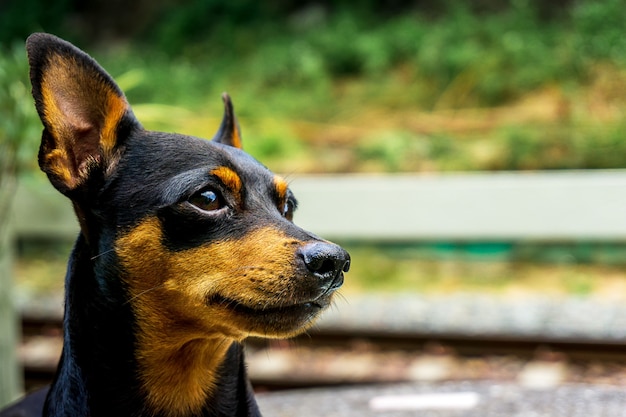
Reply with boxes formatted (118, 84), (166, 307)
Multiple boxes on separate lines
(44, 237), (260, 417)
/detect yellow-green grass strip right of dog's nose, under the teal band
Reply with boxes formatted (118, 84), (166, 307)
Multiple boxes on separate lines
(338, 246), (626, 298)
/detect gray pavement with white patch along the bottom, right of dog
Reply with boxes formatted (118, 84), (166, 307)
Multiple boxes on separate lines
(257, 382), (626, 417)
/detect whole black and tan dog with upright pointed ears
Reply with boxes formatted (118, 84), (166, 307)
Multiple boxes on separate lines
(0, 34), (350, 417)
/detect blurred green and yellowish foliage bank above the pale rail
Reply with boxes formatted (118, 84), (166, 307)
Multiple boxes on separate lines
(0, 0), (626, 172)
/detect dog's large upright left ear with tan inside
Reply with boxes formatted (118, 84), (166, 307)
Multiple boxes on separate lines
(26, 33), (140, 194)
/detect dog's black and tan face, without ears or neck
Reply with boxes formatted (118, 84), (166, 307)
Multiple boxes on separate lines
(111, 132), (349, 339)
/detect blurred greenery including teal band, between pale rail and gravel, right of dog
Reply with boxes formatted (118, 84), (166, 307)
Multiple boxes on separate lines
(344, 243), (626, 297)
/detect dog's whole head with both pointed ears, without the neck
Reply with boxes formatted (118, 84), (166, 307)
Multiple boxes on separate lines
(27, 34), (350, 343)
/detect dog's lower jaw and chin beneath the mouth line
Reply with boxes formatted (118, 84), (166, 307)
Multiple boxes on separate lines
(208, 293), (332, 338)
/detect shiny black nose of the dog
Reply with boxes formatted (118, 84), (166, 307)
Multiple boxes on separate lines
(299, 242), (350, 288)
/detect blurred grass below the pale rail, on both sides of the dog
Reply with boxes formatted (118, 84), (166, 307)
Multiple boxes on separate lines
(15, 243), (626, 299)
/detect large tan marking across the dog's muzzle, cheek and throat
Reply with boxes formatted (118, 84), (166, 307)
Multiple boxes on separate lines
(116, 218), (316, 415)
